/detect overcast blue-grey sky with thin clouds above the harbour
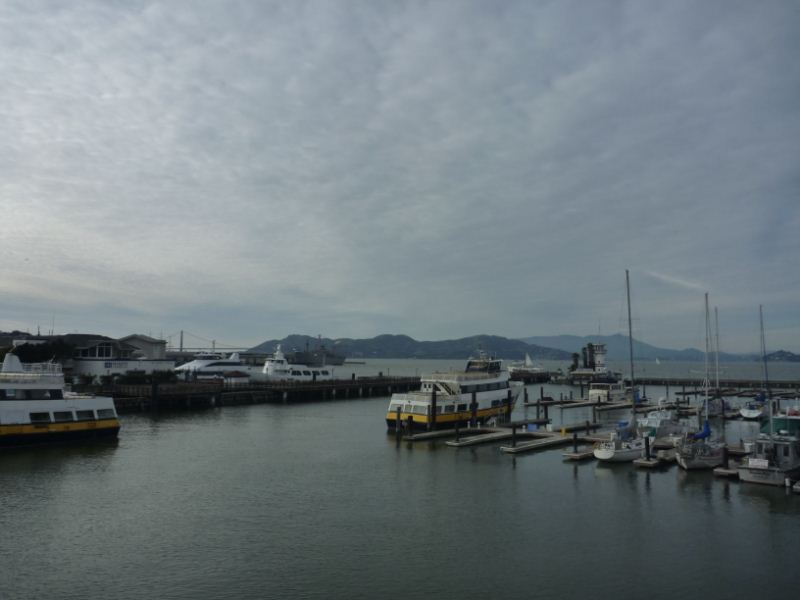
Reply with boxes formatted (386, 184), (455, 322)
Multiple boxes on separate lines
(0, 0), (800, 352)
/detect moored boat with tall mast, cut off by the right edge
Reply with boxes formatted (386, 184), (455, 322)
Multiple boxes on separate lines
(738, 306), (800, 485)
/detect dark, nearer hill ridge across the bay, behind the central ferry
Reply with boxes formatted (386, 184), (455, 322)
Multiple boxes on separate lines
(251, 334), (571, 360)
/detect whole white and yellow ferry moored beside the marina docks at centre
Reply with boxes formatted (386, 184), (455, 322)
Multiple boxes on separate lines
(386, 353), (524, 429)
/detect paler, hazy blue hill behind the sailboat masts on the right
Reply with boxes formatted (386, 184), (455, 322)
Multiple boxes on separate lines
(521, 333), (752, 361)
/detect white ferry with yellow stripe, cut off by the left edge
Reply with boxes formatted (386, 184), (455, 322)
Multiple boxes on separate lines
(0, 352), (119, 446)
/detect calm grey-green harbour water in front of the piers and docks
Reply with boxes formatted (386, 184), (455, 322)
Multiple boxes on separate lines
(0, 361), (800, 600)
